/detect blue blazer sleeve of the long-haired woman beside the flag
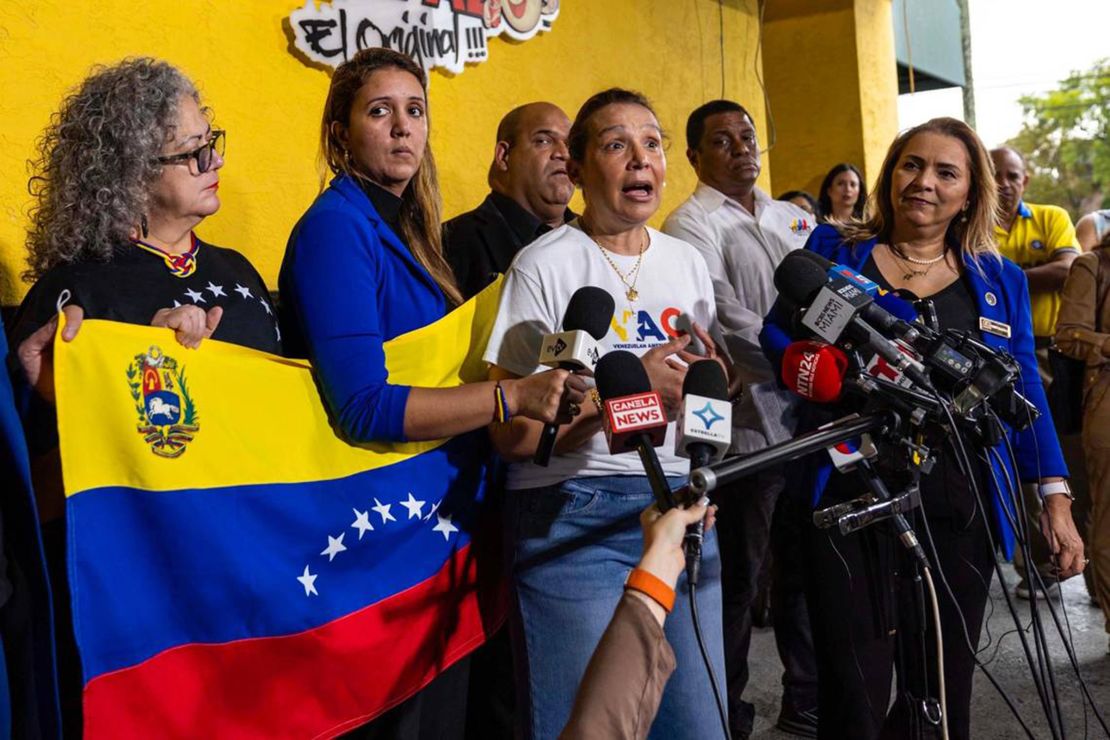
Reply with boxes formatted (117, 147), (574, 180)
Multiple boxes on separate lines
(282, 207), (411, 443)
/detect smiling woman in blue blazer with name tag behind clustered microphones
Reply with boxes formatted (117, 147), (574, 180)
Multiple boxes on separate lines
(763, 119), (1084, 738)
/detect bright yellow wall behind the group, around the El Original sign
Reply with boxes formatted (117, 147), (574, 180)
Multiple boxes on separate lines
(0, 0), (777, 305)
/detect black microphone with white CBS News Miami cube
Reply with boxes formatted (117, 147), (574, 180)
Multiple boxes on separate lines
(775, 250), (932, 388)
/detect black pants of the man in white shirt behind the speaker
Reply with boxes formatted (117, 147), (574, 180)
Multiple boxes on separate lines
(715, 470), (817, 737)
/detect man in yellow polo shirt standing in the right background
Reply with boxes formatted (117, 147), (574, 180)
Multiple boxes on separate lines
(990, 146), (1089, 599)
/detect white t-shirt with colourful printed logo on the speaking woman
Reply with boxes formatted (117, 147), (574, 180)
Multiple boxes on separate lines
(485, 222), (717, 489)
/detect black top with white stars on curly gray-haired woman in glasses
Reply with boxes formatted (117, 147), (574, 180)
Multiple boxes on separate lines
(11, 237), (281, 354)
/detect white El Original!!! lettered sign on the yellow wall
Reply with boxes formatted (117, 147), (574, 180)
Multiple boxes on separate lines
(289, 0), (559, 74)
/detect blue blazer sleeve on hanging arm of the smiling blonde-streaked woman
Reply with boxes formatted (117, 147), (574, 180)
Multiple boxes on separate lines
(1002, 260), (1068, 481)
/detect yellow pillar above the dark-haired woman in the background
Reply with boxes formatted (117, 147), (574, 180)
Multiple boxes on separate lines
(764, 0), (898, 195)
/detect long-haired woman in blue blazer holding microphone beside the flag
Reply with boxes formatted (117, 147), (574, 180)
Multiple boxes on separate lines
(279, 49), (585, 738)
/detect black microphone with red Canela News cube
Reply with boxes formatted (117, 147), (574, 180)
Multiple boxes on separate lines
(594, 349), (675, 511)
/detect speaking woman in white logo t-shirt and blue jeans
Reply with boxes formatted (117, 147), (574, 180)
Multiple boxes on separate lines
(485, 89), (724, 740)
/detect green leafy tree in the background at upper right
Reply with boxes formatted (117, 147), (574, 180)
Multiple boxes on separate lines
(1006, 59), (1110, 221)
